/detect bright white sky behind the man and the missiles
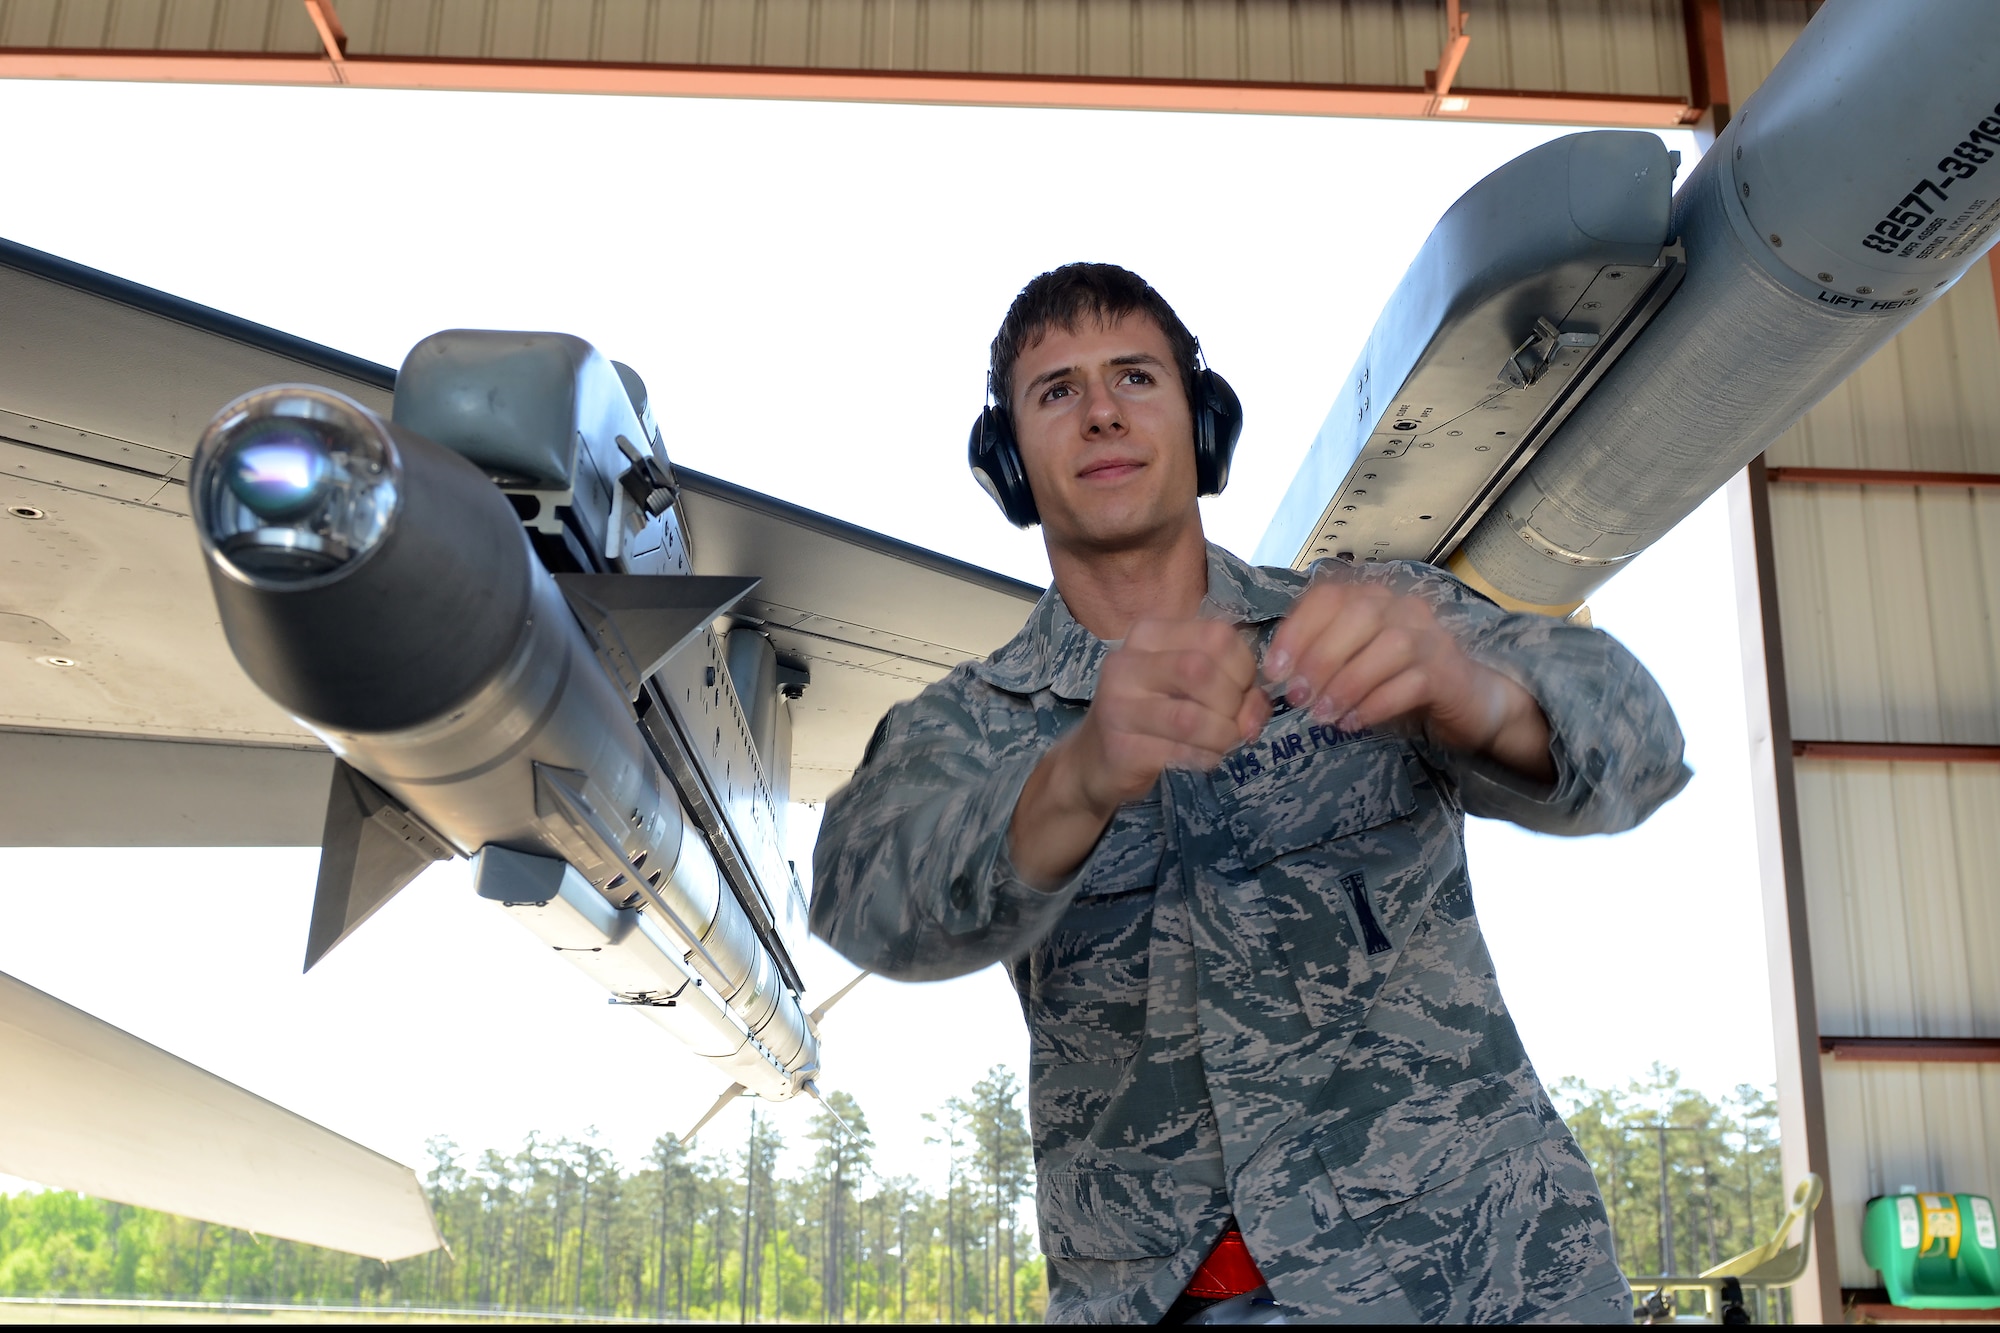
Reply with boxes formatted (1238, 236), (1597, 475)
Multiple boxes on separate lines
(0, 82), (1772, 1183)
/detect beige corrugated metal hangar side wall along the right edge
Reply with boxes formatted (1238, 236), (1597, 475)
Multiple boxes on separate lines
(1768, 252), (2000, 1287)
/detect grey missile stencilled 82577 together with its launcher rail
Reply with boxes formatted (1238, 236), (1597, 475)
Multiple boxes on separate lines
(1258, 0), (2000, 614)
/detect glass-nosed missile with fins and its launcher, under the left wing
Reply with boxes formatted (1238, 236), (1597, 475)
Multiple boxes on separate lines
(190, 330), (818, 1099)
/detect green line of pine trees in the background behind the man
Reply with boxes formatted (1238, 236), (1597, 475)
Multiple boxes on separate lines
(0, 1067), (1788, 1323)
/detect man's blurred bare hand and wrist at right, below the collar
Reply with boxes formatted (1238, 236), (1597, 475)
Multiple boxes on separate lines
(1264, 580), (1556, 783)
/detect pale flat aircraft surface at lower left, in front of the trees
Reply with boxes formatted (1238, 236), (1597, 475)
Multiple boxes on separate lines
(0, 973), (444, 1263)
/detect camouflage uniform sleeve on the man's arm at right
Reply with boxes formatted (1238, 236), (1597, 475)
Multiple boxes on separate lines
(1370, 562), (1694, 837)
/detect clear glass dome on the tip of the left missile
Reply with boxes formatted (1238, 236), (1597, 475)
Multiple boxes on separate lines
(188, 384), (402, 588)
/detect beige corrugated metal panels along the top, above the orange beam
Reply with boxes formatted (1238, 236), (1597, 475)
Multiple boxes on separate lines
(0, 0), (1720, 96)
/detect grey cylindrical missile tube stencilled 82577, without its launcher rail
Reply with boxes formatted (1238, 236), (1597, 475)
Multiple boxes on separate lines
(1450, 0), (2000, 614)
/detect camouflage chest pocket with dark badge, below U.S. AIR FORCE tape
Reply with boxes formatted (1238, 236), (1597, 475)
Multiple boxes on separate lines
(1218, 719), (1432, 1027)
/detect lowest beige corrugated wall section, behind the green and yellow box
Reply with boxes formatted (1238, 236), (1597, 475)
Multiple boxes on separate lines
(1826, 1061), (2000, 1287)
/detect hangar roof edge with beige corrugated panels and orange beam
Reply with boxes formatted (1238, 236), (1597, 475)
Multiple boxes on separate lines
(0, 0), (1752, 128)
